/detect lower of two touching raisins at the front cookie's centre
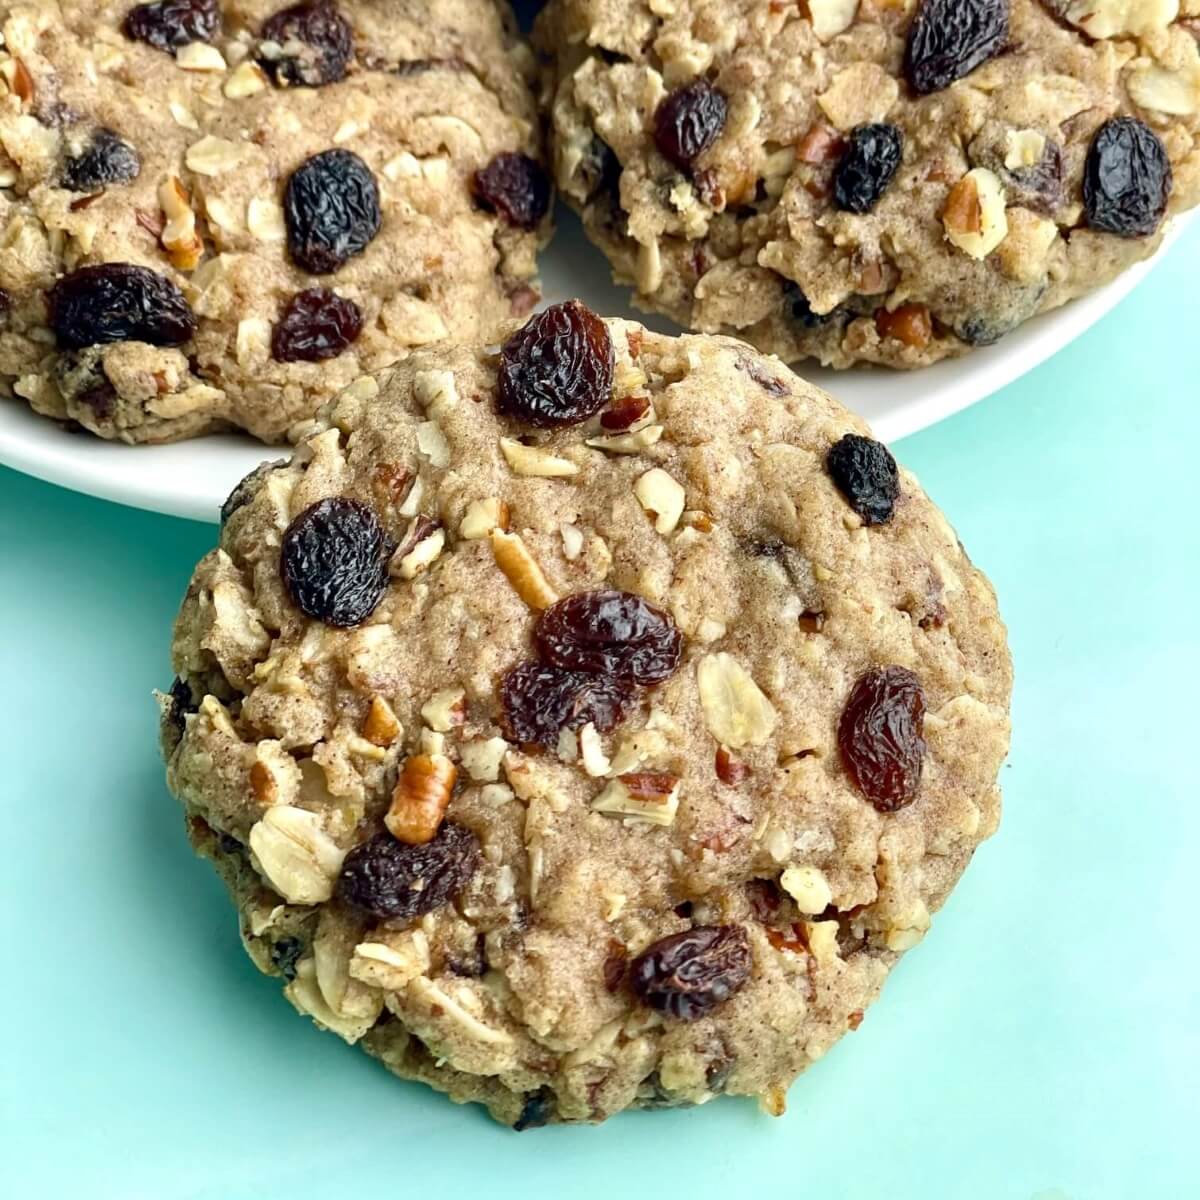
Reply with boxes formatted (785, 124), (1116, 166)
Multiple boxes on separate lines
(500, 662), (634, 749)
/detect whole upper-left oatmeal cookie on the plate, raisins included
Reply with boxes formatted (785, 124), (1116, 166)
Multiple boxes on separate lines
(0, 0), (550, 442)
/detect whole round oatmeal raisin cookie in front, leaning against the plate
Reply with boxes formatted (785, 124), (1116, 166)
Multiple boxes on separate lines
(162, 302), (1010, 1128)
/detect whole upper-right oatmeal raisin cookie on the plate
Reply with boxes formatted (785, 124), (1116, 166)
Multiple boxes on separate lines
(535, 0), (1200, 367)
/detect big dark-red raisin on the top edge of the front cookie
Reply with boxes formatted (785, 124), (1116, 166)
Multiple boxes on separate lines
(499, 300), (613, 427)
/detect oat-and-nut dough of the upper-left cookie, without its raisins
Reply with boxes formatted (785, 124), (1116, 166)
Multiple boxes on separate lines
(0, 0), (545, 442)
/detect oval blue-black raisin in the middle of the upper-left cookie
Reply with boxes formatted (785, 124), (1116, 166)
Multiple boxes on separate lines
(283, 150), (383, 275)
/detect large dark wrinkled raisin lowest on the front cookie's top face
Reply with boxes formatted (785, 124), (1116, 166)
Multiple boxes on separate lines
(629, 925), (750, 1021)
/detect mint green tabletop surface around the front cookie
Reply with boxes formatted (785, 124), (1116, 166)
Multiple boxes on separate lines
(0, 220), (1200, 1200)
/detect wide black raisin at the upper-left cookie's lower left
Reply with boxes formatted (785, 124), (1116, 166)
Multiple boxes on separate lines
(47, 263), (196, 350)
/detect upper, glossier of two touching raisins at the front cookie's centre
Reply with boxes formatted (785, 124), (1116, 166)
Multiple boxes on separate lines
(534, 592), (683, 688)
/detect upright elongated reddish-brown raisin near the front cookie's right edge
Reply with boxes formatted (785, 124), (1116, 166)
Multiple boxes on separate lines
(838, 667), (925, 812)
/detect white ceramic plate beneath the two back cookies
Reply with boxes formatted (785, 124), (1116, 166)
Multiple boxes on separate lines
(0, 208), (1186, 521)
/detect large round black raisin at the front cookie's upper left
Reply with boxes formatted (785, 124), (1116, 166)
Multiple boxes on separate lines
(280, 496), (391, 629)
